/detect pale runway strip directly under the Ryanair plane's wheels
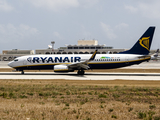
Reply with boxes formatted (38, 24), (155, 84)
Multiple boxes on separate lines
(0, 72), (160, 80)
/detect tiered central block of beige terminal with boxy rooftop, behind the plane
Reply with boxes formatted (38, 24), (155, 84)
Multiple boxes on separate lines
(35, 40), (124, 54)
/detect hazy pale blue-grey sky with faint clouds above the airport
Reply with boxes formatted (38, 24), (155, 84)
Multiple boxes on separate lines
(0, 0), (160, 53)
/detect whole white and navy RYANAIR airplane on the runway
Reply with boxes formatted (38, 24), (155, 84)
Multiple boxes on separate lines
(8, 26), (155, 75)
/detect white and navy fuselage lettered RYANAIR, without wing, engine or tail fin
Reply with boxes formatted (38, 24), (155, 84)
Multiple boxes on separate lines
(8, 54), (150, 70)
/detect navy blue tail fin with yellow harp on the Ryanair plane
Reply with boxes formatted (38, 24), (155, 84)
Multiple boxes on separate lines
(119, 27), (155, 55)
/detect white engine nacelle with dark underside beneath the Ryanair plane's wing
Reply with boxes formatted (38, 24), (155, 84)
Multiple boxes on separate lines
(54, 65), (74, 72)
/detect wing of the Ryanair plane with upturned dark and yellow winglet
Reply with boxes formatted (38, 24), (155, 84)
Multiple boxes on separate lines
(68, 50), (97, 70)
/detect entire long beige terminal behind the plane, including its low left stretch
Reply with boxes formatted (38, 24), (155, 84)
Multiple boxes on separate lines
(0, 40), (156, 61)
